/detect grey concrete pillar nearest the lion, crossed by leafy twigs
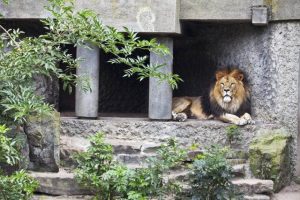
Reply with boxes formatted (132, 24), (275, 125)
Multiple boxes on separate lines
(149, 37), (173, 120)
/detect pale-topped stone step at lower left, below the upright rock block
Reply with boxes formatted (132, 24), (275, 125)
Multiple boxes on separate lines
(30, 169), (91, 195)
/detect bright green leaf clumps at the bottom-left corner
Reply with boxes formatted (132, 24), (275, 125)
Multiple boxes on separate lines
(0, 125), (38, 200)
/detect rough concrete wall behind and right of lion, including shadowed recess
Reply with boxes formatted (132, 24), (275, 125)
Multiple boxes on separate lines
(174, 22), (300, 175)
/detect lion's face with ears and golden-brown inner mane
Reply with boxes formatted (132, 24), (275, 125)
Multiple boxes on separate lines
(210, 69), (249, 113)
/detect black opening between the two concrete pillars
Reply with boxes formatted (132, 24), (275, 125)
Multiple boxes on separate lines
(99, 47), (149, 116)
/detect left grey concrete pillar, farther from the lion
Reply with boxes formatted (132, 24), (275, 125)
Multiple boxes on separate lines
(75, 45), (100, 118)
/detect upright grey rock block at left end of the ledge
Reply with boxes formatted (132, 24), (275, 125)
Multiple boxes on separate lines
(25, 112), (60, 172)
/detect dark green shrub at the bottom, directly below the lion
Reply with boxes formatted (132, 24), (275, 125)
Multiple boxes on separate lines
(190, 146), (234, 200)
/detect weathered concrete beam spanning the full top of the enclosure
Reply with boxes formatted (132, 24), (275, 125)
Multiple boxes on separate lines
(0, 0), (300, 33)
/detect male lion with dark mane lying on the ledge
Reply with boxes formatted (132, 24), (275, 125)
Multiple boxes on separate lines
(172, 68), (254, 126)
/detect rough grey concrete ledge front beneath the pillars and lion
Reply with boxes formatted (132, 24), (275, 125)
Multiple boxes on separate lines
(61, 117), (280, 149)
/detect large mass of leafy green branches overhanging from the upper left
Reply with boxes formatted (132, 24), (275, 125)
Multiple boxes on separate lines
(0, 0), (181, 124)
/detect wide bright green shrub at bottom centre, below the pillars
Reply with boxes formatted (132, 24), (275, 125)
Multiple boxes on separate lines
(74, 133), (186, 200)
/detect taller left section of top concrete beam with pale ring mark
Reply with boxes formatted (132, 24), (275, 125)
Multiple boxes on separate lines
(0, 0), (180, 33)
